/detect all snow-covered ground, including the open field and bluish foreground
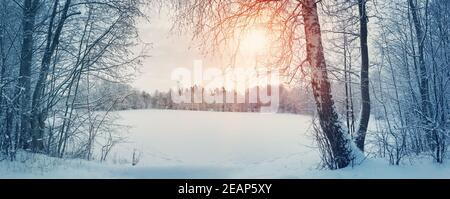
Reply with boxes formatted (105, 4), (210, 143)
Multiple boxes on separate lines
(0, 110), (450, 178)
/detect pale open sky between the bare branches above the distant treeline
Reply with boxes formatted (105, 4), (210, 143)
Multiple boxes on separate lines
(131, 8), (288, 93)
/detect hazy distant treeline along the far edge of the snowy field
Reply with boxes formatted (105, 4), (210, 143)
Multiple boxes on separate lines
(97, 83), (314, 114)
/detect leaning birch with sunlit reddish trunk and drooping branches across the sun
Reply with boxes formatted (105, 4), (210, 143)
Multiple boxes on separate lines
(172, 0), (359, 168)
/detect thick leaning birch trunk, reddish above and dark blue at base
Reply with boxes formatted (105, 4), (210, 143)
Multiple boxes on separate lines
(302, 0), (353, 168)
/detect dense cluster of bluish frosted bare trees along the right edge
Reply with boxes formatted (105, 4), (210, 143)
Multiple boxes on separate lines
(373, 0), (449, 164)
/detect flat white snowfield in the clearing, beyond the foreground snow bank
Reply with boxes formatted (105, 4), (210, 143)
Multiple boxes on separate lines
(110, 110), (319, 177)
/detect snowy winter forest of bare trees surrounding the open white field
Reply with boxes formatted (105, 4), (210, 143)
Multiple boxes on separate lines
(0, 0), (450, 173)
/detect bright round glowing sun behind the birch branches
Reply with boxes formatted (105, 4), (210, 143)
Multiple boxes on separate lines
(240, 28), (268, 54)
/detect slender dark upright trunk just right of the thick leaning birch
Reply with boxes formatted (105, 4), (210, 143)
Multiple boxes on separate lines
(355, 0), (370, 151)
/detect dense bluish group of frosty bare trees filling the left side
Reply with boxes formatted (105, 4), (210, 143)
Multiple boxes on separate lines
(0, 0), (148, 159)
